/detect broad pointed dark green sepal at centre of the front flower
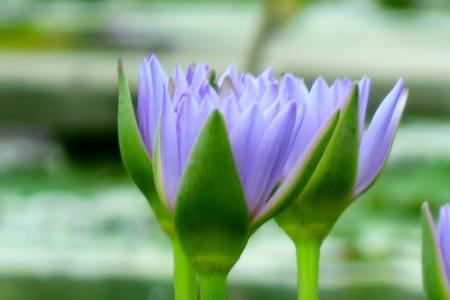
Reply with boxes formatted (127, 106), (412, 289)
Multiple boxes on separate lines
(175, 110), (249, 274)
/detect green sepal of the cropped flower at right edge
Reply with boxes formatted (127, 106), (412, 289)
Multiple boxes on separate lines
(422, 202), (450, 300)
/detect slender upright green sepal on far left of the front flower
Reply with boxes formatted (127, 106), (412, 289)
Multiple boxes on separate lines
(117, 60), (174, 235)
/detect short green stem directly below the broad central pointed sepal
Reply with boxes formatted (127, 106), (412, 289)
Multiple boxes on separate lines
(199, 274), (227, 300)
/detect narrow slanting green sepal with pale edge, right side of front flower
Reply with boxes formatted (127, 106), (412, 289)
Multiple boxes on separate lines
(251, 111), (339, 232)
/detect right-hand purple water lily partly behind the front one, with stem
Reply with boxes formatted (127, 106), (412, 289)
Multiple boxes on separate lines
(276, 77), (407, 300)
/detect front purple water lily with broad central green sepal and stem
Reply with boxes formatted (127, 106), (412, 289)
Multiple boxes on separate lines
(119, 56), (339, 300)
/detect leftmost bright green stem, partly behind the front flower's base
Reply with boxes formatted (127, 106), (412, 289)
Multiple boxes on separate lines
(172, 238), (198, 300)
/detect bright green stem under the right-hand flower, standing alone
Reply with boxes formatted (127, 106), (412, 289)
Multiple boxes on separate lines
(296, 239), (320, 300)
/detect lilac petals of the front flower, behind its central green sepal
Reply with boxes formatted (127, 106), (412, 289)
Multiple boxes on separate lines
(138, 56), (310, 214)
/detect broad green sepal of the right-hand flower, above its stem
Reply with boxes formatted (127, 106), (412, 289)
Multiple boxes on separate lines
(276, 85), (359, 241)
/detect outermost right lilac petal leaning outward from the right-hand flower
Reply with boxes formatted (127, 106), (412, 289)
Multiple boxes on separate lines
(354, 80), (407, 197)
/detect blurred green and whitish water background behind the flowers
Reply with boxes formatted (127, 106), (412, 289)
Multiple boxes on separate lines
(0, 0), (450, 300)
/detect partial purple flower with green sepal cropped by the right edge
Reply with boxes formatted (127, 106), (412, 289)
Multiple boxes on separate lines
(422, 203), (450, 300)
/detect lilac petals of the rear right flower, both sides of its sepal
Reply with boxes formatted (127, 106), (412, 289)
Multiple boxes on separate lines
(285, 77), (407, 198)
